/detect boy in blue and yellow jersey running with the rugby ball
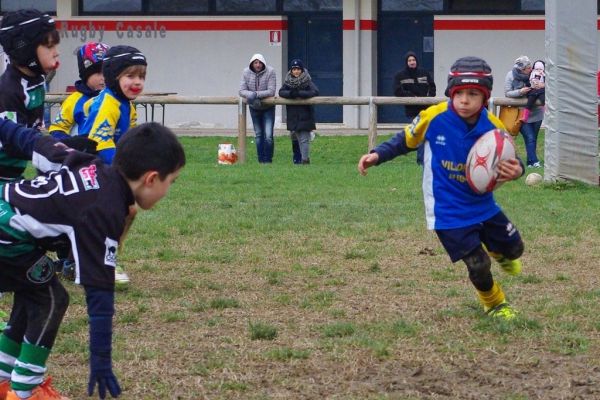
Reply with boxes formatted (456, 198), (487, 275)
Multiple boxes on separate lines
(358, 57), (524, 320)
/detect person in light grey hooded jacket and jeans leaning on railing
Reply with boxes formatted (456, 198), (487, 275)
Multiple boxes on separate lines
(239, 53), (277, 164)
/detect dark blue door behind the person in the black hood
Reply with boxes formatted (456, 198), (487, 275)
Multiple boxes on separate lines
(377, 13), (434, 123)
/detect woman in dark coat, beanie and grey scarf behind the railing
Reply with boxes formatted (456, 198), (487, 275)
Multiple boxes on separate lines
(279, 58), (319, 164)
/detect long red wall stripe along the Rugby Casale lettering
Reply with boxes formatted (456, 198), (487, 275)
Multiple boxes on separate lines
(57, 20), (288, 31)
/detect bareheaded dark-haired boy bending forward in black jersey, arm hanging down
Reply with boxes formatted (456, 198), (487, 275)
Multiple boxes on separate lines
(0, 121), (185, 400)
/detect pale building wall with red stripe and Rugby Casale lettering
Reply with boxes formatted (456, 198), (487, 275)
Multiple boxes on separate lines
(50, 16), (287, 128)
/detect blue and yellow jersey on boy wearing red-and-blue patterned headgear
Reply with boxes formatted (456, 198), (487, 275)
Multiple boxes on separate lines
(48, 81), (100, 140)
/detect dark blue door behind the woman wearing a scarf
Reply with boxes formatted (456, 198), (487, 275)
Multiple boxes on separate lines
(282, 13), (344, 123)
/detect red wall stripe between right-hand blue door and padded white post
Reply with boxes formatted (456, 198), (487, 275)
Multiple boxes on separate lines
(433, 19), (546, 31)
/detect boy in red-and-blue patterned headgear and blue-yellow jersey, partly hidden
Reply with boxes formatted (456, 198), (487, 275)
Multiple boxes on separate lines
(48, 42), (109, 142)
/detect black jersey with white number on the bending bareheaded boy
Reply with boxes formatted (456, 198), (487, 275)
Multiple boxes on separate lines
(0, 120), (134, 289)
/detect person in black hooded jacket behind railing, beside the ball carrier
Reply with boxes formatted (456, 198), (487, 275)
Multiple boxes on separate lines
(394, 51), (435, 165)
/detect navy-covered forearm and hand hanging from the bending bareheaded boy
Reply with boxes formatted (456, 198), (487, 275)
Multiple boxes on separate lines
(84, 286), (121, 399)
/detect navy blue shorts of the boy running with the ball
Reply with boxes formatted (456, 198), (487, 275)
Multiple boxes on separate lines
(435, 211), (522, 262)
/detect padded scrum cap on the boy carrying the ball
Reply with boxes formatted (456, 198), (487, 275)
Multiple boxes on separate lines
(445, 57), (494, 101)
